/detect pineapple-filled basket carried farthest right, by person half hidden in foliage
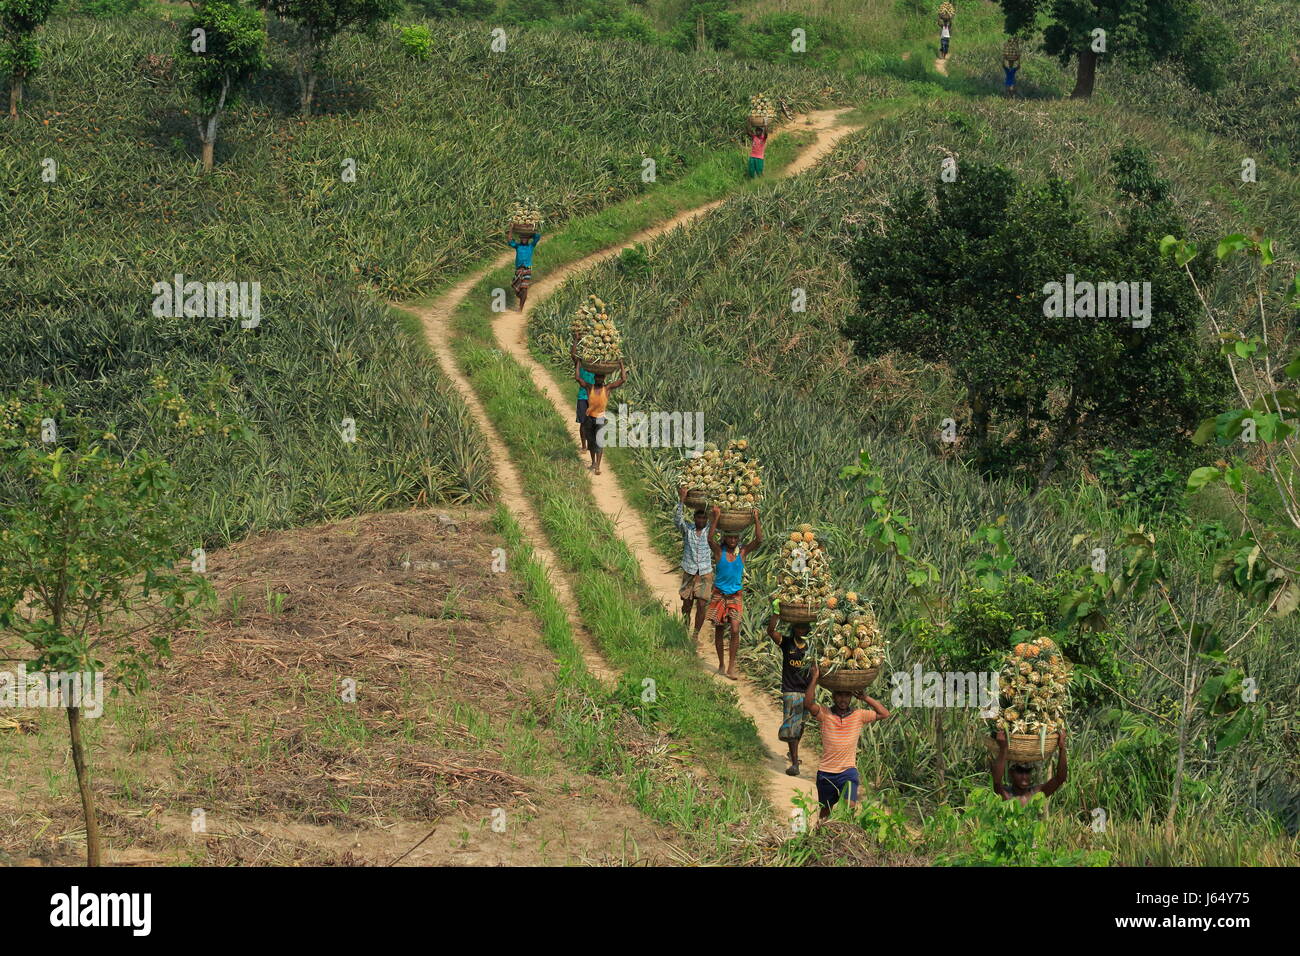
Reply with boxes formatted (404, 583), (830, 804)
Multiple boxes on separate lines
(985, 636), (1070, 763)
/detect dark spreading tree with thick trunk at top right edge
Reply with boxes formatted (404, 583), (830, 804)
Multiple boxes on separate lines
(998, 0), (1230, 99)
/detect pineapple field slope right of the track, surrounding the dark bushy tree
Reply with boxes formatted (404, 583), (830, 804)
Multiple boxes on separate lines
(533, 101), (1296, 858)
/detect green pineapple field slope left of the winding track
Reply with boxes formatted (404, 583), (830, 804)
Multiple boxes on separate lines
(0, 17), (847, 540)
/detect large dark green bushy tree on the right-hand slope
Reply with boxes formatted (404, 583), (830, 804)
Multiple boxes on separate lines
(845, 163), (1225, 486)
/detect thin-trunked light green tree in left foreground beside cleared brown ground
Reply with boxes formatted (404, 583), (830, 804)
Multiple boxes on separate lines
(0, 393), (212, 866)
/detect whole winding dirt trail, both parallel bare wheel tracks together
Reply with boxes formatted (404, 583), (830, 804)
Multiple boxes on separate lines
(410, 109), (861, 816)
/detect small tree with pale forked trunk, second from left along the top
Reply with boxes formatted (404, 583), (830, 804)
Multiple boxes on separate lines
(181, 0), (267, 172)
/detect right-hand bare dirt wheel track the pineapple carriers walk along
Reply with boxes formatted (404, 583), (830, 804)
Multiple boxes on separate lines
(480, 111), (858, 814)
